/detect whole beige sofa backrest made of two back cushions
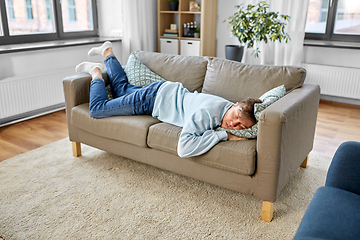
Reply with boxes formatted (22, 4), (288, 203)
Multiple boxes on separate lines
(134, 51), (306, 102)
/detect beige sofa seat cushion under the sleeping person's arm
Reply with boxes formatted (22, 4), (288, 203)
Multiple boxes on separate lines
(148, 123), (256, 175)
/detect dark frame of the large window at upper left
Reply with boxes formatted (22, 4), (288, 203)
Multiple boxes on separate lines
(0, 0), (99, 45)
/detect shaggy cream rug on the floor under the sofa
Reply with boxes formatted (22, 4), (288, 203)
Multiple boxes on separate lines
(0, 139), (331, 240)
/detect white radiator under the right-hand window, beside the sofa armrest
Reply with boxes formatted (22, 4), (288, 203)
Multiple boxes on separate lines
(302, 63), (360, 99)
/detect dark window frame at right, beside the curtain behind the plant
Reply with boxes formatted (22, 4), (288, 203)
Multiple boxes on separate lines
(305, 0), (360, 42)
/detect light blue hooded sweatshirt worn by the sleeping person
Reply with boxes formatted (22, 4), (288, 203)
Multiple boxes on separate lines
(152, 82), (234, 157)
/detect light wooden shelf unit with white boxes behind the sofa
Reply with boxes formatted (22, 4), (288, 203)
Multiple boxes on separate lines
(158, 0), (217, 56)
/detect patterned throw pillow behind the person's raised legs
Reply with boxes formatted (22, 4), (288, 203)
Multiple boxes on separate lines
(125, 53), (165, 87)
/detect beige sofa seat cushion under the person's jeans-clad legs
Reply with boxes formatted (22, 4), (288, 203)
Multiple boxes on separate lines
(71, 103), (160, 147)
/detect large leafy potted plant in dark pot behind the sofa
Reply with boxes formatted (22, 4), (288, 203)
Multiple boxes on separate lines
(224, 2), (291, 62)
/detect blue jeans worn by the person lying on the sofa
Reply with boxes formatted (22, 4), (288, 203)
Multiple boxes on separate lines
(89, 55), (165, 118)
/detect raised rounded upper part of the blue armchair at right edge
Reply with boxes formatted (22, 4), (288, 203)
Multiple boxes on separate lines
(325, 141), (360, 195)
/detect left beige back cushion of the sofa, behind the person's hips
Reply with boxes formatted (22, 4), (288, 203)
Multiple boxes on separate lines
(134, 51), (208, 92)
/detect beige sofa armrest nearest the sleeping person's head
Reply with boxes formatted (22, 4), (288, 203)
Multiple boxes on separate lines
(257, 84), (320, 202)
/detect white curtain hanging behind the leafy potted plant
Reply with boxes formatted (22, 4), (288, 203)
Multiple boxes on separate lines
(242, 0), (309, 66)
